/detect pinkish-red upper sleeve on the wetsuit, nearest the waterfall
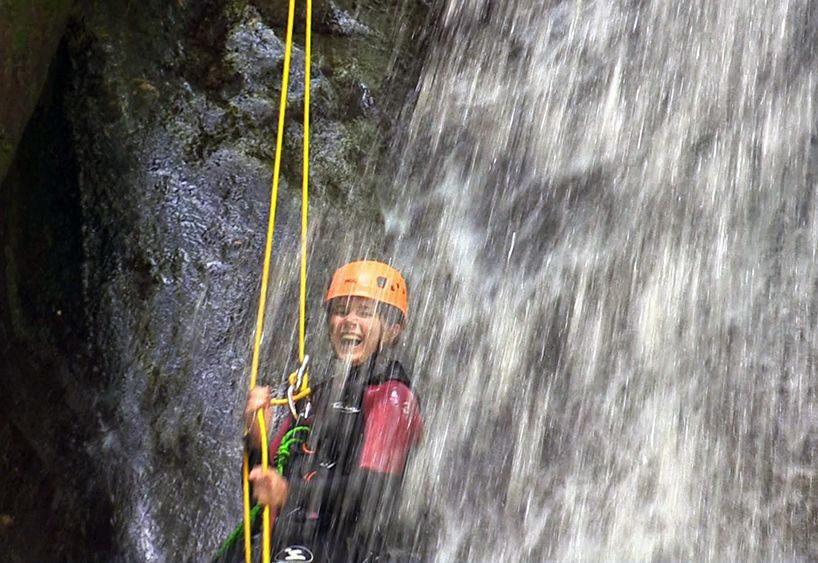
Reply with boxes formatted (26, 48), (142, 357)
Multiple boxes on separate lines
(360, 381), (423, 475)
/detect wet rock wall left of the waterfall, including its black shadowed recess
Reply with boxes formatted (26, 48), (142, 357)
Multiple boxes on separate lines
(0, 0), (432, 561)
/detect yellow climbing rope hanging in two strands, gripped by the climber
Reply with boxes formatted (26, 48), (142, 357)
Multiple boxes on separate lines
(242, 0), (312, 563)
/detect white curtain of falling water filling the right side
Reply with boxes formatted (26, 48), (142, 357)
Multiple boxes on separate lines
(387, 0), (818, 561)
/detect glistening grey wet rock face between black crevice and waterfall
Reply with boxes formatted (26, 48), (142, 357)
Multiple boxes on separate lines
(28, 0), (427, 561)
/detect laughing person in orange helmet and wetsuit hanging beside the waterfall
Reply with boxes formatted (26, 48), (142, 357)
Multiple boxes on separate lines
(244, 260), (422, 562)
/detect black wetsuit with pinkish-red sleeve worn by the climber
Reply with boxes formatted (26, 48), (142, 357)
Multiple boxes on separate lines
(247, 362), (422, 562)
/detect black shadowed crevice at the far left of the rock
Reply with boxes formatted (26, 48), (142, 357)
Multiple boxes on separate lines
(0, 40), (112, 561)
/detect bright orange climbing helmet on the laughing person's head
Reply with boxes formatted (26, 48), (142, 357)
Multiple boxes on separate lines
(324, 260), (409, 319)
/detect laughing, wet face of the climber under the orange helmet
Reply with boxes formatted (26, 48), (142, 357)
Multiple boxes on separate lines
(329, 297), (384, 366)
